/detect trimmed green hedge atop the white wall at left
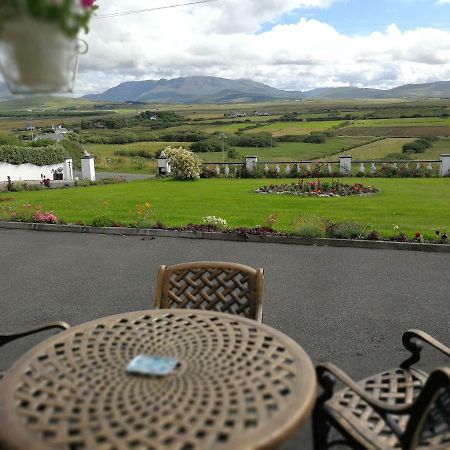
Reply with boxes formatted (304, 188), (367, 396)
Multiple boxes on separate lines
(0, 144), (68, 166)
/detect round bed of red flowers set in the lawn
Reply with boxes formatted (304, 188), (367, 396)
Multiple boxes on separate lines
(256, 180), (378, 197)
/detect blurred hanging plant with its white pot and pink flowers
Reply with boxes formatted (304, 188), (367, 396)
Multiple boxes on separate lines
(0, 0), (97, 94)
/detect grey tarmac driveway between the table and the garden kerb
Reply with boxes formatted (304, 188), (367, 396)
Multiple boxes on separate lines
(0, 229), (450, 450)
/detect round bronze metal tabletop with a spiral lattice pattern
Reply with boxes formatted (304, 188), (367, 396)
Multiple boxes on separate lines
(0, 309), (316, 450)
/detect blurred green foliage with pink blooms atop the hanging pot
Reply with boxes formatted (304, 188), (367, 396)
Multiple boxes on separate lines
(0, 0), (98, 38)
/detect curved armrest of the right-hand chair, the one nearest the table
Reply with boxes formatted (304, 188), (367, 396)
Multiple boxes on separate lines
(316, 363), (413, 415)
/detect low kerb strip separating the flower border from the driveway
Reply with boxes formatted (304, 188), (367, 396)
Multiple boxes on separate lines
(0, 221), (450, 253)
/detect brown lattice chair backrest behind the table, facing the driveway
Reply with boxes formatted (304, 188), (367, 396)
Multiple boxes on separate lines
(155, 261), (264, 322)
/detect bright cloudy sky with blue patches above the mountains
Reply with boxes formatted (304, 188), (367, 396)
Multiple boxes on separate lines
(77, 0), (450, 93)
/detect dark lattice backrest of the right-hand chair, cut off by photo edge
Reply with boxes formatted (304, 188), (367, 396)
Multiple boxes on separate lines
(405, 368), (450, 450)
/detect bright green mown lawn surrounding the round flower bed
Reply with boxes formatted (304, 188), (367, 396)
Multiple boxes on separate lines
(2, 178), (450, 237)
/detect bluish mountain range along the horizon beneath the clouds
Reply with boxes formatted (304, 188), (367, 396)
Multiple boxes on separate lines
(83, 76), (450, 103)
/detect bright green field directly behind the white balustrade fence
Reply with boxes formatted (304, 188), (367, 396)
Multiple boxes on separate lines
(198, 137), (370, 162)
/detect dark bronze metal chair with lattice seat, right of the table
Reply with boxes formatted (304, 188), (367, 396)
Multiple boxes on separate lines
(313, 330), (450, 450)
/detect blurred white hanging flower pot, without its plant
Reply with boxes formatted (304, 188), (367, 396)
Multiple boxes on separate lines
(0, 17), (79, 94)
